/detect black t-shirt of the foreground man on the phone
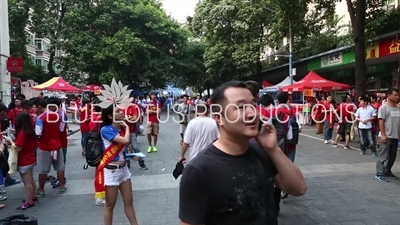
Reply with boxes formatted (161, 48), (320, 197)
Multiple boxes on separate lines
(179, 145), (277, 225)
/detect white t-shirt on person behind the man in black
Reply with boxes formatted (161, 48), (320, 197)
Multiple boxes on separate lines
(183, 116), (219, 163)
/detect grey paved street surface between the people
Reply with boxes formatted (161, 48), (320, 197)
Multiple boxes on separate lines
(0, 116), (400, 225)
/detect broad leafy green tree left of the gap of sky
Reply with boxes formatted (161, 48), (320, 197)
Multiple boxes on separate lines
(63, 0), (187, 88)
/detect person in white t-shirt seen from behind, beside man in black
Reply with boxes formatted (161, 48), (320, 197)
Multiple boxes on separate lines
(178, 102), (219, 163)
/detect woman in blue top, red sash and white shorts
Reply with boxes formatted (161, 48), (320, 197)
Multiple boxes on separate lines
(95, 105), (138, 225)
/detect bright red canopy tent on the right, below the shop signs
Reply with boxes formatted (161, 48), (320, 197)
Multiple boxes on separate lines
(279, 71), (350, 92)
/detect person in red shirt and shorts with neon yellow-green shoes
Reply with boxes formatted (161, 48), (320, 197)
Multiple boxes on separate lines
(146, 93), (161, 153)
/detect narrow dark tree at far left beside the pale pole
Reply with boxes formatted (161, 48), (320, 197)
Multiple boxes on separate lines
(8, 0), (49, 82)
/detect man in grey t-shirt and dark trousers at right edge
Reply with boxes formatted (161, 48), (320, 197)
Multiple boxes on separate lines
(375, 88), (400, 182)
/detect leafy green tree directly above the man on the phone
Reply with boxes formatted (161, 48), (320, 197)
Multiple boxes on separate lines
(189, 0), (271, 82)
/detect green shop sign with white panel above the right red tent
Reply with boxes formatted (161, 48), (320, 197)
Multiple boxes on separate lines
(307, 52), (354, 71)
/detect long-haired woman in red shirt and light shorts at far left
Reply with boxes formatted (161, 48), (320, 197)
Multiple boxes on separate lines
(13, 112), (37, 211)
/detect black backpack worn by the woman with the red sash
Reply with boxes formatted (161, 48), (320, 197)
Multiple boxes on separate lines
(83, 124), (103, 170)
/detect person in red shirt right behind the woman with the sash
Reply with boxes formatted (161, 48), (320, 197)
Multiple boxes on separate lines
(124, 99), (148, 170)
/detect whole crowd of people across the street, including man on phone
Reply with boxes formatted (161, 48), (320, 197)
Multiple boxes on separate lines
(0, 84), (400, 225)
